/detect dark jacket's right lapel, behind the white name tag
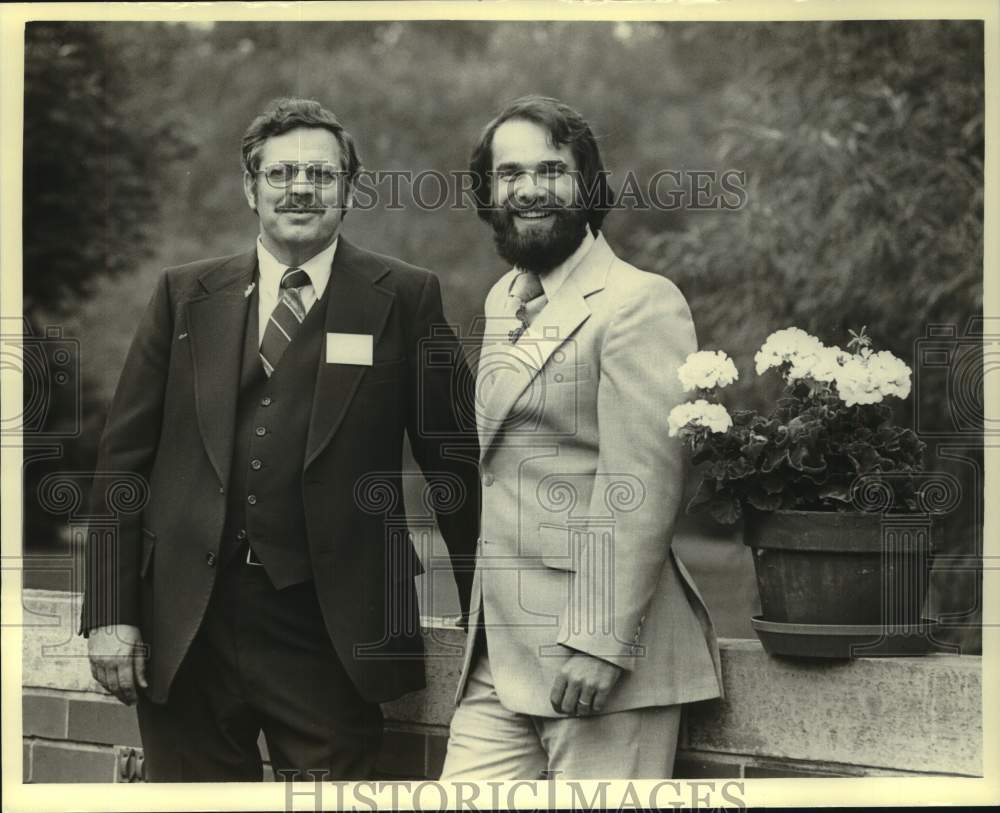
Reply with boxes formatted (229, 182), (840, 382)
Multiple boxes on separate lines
(304, 238), (395, 467)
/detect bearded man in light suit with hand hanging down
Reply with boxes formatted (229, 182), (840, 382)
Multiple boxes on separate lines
(442, 96), (722, 780)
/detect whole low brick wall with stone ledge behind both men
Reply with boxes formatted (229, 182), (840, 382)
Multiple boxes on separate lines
(22, 590), (982, 776)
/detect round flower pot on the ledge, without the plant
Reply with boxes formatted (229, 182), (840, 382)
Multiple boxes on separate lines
(744, 511), (936, 657)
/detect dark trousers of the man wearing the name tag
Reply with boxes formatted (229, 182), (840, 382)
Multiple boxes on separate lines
(138, 555), (382, 782)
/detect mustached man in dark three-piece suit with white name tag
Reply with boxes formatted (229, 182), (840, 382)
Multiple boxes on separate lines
(81, 99), (478, 782)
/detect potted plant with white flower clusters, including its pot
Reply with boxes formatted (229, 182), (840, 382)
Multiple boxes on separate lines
(668, 327), (934, 657)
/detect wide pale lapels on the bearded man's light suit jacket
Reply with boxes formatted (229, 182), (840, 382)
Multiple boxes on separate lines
(477, 235), (616, 460)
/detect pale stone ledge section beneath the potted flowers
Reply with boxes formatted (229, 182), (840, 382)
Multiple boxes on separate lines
(683, 640), (982, 776)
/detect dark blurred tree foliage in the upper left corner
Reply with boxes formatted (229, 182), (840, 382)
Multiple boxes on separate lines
(23, 22), (194, 314)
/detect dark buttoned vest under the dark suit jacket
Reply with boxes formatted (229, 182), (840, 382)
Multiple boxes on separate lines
(220, 286), (329, 590)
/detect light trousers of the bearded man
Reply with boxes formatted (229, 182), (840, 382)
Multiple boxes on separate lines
(441, 653), (681, 781)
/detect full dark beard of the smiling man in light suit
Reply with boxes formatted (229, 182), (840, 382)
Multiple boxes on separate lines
(490, 201), (587, 274)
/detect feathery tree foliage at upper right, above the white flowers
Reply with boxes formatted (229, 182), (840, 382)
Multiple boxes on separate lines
(634, 21), (984, 432)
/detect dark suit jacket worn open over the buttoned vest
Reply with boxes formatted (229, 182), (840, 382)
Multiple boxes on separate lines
(81, 238), (478, 702)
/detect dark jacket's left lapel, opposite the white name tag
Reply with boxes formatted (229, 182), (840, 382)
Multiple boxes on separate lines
(185, 250), (257, 486)
